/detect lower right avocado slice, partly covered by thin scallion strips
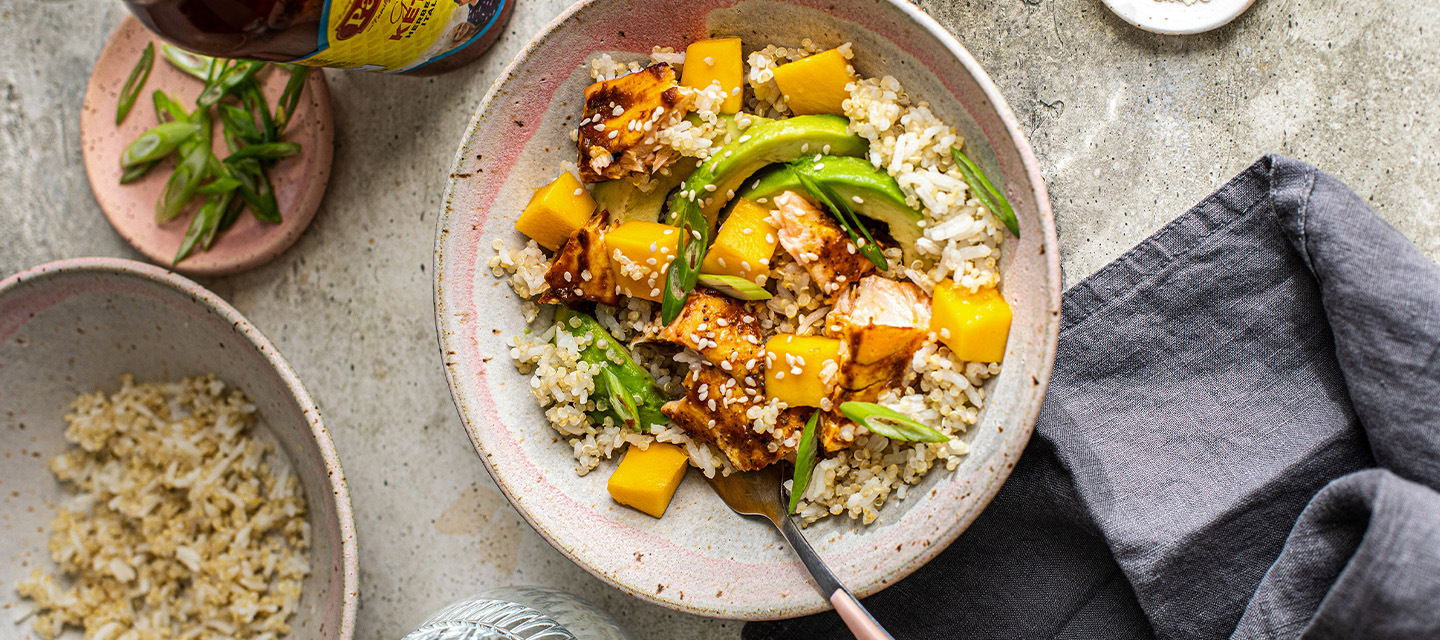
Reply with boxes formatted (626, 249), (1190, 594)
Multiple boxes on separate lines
(739, 156), (924, 265)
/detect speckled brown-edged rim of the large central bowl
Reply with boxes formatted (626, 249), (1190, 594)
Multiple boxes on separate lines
(431, 0), (1061, 620)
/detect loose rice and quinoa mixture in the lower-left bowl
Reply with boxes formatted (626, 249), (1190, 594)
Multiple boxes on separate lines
(19, 376), (310, 640)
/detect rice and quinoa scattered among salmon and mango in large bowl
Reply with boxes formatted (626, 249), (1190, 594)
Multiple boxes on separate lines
(490, 39), (1005, 523)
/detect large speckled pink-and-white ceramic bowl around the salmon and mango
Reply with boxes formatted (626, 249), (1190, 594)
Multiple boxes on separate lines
(435, 0), (1060, 620)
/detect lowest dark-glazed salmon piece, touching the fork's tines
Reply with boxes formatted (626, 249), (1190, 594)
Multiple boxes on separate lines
(660, 366), (808, 471)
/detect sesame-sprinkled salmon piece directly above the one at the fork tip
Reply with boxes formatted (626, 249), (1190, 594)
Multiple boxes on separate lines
(657, 288), (765, 383)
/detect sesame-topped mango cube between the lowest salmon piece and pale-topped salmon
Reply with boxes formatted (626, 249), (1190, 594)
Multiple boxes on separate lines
(765, 334), (840, 406)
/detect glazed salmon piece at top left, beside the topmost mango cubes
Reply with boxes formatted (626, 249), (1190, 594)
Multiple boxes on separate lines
(579, 63), (693, 182)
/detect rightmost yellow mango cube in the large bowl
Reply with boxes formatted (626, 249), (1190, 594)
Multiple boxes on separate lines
(930, 280), (1012, 362)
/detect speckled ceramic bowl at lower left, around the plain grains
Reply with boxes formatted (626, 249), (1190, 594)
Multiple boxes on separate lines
(0, 258), (359, 640)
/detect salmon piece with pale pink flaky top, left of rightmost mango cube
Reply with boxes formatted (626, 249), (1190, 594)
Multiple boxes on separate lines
(825, 275), (930, 391)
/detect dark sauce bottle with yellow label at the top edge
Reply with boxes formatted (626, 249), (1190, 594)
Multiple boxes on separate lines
(125, 0), (516, 75)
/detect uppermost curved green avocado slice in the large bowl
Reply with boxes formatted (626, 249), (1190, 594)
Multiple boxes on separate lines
(668, 115), (870, 232)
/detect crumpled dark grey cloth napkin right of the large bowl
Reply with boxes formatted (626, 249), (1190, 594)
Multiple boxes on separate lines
(744, 156), (1440, 639)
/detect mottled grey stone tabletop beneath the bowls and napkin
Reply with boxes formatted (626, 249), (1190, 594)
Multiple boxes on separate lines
(0, 0), (1440, 640)
